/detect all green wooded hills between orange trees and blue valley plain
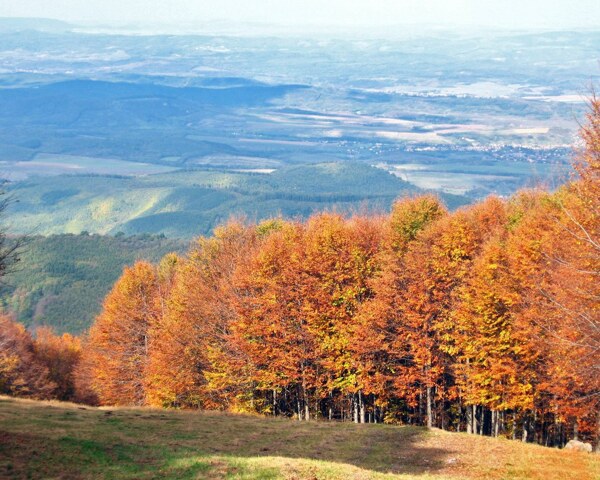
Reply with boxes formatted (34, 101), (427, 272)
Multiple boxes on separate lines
(0, 163), (466, 333)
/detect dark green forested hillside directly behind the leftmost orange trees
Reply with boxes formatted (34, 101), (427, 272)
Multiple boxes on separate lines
(0, 234), (187, 334)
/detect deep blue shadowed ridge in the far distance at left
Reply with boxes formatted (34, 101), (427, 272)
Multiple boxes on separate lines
(0, 79), (303, 163)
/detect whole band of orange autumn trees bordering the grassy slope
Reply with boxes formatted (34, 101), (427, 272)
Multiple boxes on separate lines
(0, 98), (600, 446)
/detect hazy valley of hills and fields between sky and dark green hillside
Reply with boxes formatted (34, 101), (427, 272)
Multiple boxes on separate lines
(0, 25), (598, 237)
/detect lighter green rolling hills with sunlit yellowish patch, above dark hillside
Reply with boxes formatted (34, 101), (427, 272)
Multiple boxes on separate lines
(7, 163), (466, 238)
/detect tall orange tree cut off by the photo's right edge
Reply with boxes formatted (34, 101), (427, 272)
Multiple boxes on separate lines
(546, 95), (600, 442)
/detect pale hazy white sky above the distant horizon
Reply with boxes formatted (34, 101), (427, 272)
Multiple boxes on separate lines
(0, 0), (600, 29)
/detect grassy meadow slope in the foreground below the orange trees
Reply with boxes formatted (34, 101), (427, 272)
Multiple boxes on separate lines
(0, 396), (600, 480)
